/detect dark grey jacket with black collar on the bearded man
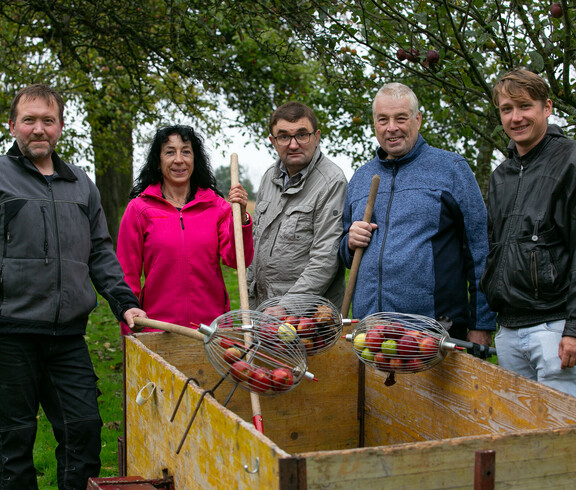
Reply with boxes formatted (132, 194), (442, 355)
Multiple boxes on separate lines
(0, 143), (139, 335)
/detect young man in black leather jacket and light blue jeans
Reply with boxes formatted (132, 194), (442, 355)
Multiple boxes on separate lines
(481, 69), (576, 395)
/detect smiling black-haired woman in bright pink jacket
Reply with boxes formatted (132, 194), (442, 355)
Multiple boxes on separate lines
(117, 125), (254, 335)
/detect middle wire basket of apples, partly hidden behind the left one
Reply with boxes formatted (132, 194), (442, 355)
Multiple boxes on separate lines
(257, 294), (358, 356)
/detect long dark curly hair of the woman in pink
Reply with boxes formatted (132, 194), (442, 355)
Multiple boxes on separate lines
(130, 124), (223, 201)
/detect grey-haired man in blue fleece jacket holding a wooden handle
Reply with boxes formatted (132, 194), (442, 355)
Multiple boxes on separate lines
(340, 83), (496, 345)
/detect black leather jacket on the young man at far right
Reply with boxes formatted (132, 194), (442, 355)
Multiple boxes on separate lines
(481, 125), (576, 337)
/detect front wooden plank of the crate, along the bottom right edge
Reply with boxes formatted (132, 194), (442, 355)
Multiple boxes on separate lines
(298, 427), (576, 490)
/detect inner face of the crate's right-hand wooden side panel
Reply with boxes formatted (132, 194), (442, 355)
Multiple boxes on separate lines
(366, 353), (576, 446)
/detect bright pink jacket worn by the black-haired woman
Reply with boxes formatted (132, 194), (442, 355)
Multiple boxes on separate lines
(117, 183), (254, 335)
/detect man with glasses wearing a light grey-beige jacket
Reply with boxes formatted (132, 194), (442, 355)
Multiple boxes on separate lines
(248, 102), (347, 308)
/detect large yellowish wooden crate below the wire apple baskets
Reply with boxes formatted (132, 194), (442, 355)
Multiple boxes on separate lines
(125, 333), (576, 490)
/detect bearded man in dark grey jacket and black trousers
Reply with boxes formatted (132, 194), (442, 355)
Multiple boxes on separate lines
(0, 84), (146, 490)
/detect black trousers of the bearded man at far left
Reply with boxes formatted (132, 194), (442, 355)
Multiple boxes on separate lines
(0, 335), (102, 490)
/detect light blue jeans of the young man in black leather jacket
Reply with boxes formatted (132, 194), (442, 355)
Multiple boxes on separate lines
(495, 320), (576, 396)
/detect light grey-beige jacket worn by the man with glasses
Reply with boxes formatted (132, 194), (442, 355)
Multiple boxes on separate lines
(248, 147), (347, 308)
